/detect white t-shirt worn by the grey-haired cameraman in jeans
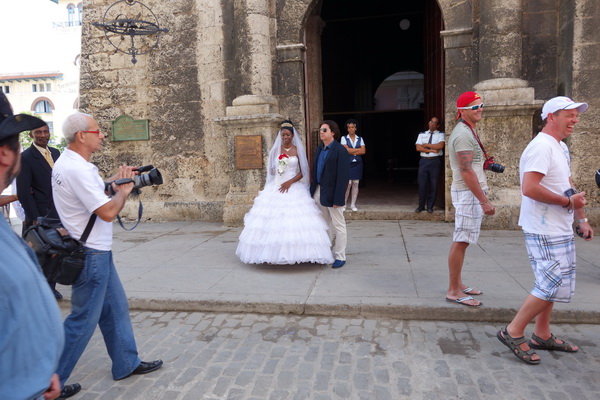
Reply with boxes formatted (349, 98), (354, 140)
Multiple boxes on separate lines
(52, 149), (113, 251)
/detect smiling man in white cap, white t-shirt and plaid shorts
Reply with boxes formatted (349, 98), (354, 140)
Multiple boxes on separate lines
(497, 96), (594, 364)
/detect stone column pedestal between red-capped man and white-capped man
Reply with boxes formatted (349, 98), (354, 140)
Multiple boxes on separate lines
(475, 78), (544, 229)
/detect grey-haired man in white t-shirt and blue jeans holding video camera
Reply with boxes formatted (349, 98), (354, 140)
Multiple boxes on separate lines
(52, 113), (162, 397)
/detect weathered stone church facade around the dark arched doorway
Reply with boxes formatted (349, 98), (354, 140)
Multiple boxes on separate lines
(80, 0), (600, 228)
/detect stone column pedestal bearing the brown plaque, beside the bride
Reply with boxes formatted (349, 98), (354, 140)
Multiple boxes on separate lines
(214, 95), (284, 226)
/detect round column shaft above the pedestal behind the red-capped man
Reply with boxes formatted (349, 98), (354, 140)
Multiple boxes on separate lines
(478, 0), (522, 81)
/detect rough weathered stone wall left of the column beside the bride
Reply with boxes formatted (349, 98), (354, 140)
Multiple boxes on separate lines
(81, 0), (233, 221)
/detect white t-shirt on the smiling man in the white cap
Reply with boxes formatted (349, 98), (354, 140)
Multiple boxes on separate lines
(519, 132), (573, 235)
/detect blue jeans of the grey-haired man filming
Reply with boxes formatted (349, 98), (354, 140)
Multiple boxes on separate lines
(56, 248), (141, 386)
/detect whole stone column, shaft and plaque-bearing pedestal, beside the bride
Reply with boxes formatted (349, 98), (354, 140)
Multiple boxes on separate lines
(214, 0), (284, 226)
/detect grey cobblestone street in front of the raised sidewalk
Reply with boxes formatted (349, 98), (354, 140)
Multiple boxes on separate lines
(68, 312), (600, 400)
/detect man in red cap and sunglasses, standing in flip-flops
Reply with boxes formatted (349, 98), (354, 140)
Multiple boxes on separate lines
(446, 92), (496, 307)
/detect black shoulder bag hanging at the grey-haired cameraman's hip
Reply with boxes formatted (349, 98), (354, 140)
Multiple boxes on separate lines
(23, 214), (96, 285)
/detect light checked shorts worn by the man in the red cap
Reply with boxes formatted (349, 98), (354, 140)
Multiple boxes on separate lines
(450, 189), (483, 244)
